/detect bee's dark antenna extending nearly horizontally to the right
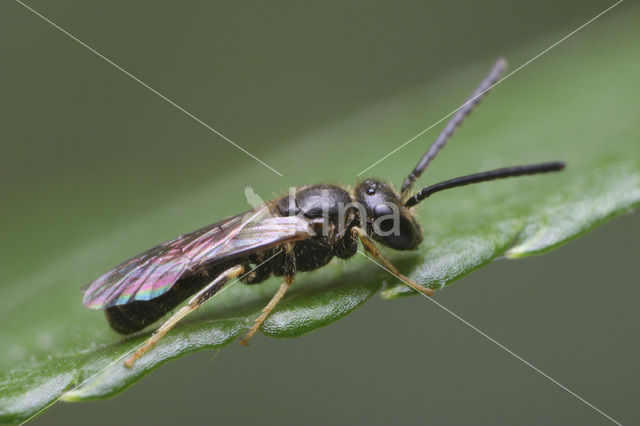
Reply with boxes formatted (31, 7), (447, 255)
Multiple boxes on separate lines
(404, 161), (565, 207)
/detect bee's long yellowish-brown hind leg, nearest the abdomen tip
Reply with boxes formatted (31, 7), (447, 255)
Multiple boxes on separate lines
(124, 265), (246, 368)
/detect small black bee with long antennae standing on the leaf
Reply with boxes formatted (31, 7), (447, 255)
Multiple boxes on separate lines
(83, 59), (564, 367)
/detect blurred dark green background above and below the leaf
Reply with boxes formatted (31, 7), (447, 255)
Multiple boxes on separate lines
(0, 0), (640, 424)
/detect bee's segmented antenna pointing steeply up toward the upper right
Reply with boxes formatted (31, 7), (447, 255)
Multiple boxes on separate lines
(401, 58), (507, 195)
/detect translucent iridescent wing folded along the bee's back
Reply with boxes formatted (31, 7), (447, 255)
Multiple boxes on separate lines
(83, 206), (315, 309)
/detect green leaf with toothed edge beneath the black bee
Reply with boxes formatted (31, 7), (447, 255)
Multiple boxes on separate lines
(0, 11), (640, 422)
